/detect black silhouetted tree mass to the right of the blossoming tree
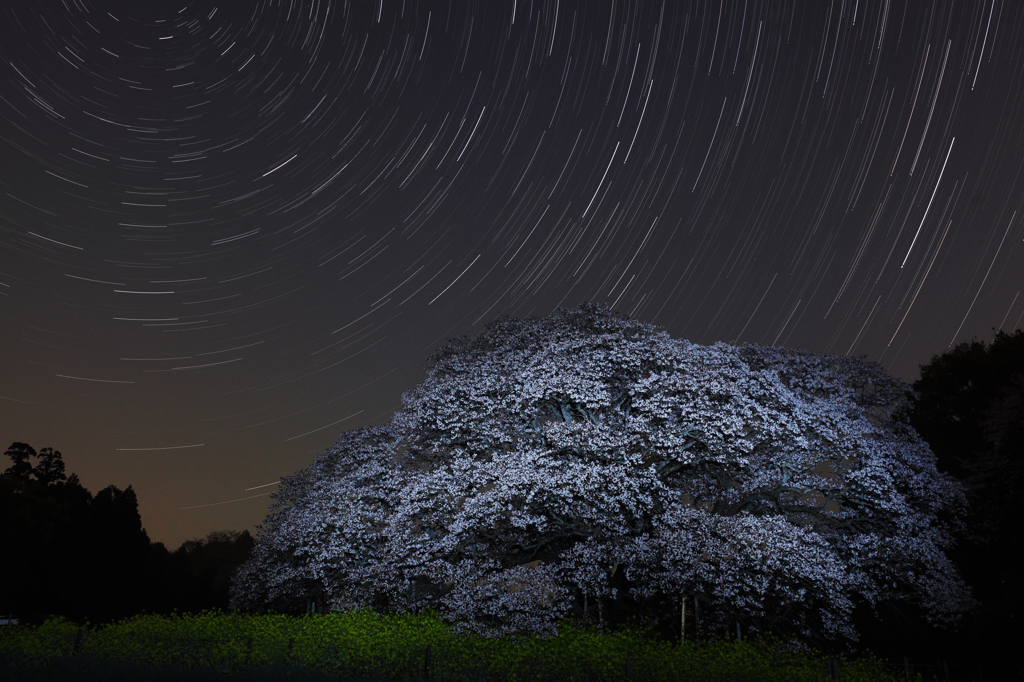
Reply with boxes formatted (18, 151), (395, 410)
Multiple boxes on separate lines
(856, 330), (1024, 666)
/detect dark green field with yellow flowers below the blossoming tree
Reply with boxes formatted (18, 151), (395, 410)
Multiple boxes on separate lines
(0, 611), (912, 682)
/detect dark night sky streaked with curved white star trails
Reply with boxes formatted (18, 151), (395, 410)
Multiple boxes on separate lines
(0, 0), (1024, 548)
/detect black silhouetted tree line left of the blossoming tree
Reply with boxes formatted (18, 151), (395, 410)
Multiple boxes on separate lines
(0, 442), (253, 624)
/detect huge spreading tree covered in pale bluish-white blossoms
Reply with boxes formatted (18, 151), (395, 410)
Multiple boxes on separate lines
(233, 306), (971, 639)
